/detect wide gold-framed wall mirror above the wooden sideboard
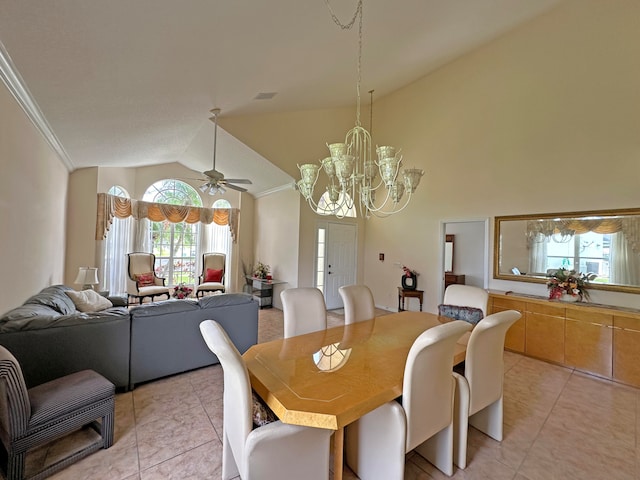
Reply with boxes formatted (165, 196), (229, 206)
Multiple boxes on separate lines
(493, 209), (640, 293)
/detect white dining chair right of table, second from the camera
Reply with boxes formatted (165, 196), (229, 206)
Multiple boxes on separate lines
(453, 310), (522, 468)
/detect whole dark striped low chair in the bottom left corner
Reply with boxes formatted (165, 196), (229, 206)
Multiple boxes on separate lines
(0, 346), (115, 480)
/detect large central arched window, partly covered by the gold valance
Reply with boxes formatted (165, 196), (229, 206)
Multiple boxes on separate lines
(142, 179), (202, 286)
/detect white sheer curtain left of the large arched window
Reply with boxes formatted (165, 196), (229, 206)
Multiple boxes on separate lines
(101, 217), (133, 295)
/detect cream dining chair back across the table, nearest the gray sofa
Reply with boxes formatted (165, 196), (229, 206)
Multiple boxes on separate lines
(280, 288), (327, 338)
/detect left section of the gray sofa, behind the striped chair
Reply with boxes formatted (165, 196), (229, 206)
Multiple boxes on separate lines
(0, 285), (131, 388)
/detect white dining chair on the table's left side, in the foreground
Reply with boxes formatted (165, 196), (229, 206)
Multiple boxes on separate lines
(200, 320), (332, 480)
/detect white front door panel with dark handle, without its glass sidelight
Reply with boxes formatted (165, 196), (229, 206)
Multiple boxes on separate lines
(324, 223), (357, 309)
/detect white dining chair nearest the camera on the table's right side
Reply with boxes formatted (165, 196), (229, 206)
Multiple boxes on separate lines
(345, 320), (471, 480)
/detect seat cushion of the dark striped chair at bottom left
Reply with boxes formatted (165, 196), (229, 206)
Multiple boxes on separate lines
(29, 370), (115, 429)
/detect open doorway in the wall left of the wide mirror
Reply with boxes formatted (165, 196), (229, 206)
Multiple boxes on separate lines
(440, 219), (489, 298)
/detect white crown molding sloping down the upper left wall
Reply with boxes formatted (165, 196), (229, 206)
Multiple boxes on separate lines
(0, 42), (75, 172)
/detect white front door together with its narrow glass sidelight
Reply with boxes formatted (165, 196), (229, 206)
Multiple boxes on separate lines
(315, 222), (358, 310)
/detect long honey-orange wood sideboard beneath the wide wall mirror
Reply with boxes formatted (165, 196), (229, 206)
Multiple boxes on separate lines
(488, 292), (640, 387)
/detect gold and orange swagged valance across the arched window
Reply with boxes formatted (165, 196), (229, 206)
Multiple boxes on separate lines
(96, 193), (240, 243)
